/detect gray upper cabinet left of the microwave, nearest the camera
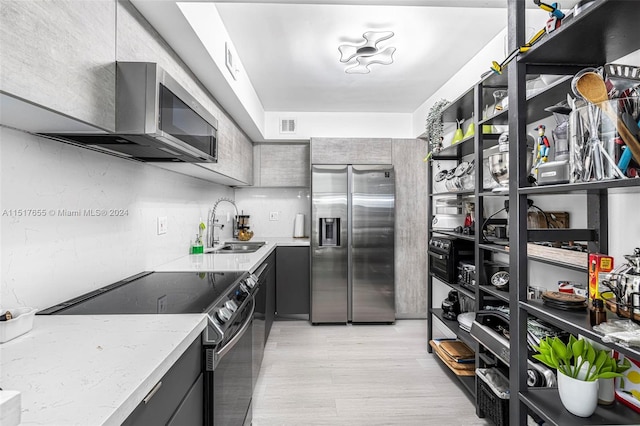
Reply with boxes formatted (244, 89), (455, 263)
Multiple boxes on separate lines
(0, 0), (116, 130)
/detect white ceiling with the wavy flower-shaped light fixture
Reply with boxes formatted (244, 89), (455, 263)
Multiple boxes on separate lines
(130, 0), (577, 141)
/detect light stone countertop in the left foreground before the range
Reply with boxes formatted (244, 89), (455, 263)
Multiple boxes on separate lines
(0, 314), (207, 426)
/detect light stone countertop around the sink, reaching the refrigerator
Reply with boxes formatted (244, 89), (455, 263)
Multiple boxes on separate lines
(154, 238), (309, 272)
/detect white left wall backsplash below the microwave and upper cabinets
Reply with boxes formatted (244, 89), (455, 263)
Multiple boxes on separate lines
(0, 127), (233, 308)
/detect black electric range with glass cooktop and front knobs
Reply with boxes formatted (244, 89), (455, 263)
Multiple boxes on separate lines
(38, 271), (260, 426)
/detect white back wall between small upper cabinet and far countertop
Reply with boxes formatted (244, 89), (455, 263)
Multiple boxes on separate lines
(235, 188), (311, 240)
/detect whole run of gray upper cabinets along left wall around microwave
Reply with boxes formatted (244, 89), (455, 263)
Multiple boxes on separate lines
(0, 0), (253, 186)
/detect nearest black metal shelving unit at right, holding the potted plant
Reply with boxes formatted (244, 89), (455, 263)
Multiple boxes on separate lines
(508, 0), (640, 426)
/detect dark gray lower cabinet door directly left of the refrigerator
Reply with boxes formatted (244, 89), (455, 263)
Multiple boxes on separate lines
(276, 247), (310, 316)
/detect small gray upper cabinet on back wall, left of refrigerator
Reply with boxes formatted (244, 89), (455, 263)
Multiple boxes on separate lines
(253, 143), (310, 187)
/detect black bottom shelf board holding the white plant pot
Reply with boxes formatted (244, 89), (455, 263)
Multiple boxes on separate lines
(519, 388), (640, 426)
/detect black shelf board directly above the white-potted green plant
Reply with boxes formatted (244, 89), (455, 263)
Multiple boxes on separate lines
(520, 300), (640, 359)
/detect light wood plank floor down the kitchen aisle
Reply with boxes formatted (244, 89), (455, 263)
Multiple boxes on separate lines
(253, 320), (489, 426)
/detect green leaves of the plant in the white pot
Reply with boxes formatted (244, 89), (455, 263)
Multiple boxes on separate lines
(533, 335), (631, 382)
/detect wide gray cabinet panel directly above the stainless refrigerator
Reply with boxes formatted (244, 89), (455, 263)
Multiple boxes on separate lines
(311, 138), (393, 164)
